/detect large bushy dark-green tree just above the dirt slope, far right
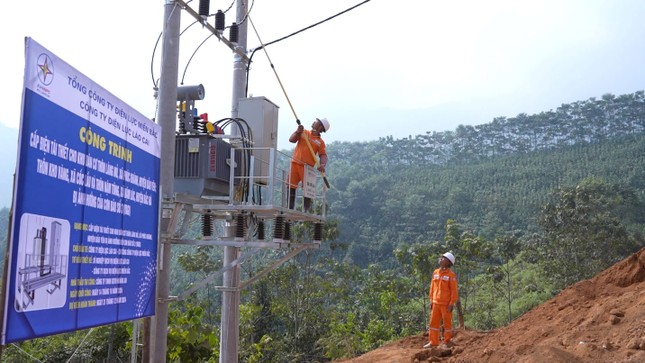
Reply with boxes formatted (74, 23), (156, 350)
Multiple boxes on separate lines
(536, 178), (643, 289)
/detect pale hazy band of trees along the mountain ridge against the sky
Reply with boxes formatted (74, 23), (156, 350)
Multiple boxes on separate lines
(340, 91), (645, 167)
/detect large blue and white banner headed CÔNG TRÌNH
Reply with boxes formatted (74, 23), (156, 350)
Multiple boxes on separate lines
(2, 38), (161, 344)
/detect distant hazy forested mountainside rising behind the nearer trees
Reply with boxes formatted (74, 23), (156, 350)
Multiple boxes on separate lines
(327, 92), (645, 266)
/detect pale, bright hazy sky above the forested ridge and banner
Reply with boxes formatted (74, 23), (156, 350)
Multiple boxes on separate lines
(0, 0), (645, 149)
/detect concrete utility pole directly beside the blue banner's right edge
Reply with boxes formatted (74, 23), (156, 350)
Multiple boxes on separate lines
(150, 0), (181, 363)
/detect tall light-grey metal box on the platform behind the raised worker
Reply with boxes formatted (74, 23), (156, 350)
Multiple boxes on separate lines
(238, 97), (279, 184)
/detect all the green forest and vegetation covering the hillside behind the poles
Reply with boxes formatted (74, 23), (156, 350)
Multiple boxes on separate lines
(0, 91), (645, 362)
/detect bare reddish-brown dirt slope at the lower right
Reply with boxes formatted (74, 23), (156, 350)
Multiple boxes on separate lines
(337, 248), (645, 363)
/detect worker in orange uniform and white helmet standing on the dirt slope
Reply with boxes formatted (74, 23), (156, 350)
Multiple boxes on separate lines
(423, 252), (459, 348)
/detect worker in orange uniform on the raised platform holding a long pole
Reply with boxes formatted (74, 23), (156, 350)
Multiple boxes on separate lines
(289, 118), (329, 212)
